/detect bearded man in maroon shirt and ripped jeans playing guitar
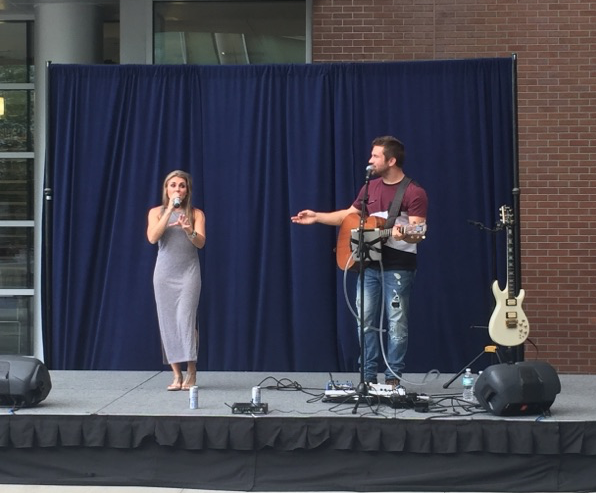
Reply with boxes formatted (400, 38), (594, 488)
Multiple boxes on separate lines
(292, 136), (428, 387)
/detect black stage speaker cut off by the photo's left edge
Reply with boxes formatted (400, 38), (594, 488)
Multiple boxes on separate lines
(0, 355), (52, 407)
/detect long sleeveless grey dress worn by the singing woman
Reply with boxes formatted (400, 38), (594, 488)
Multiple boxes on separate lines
(153, 211), (201, 364)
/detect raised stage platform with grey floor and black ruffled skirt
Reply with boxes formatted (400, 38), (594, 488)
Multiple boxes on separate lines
(0, 371), (596, 492)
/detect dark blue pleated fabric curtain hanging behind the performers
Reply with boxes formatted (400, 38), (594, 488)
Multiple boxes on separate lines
(45, 59), (513, 372)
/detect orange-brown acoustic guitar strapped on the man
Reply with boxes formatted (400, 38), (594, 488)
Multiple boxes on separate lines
(335, 212), (426, 271)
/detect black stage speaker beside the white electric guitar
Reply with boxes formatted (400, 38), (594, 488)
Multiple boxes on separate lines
(474, 361), (561, 416)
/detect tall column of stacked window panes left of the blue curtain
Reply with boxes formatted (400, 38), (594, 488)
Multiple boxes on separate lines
(0, 21), (34, 355)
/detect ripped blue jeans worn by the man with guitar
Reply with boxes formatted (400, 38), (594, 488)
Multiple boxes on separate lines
(356, 268), (416, 382)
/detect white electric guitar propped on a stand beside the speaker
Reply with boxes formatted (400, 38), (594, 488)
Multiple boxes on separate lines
(488, 206), (530, 346)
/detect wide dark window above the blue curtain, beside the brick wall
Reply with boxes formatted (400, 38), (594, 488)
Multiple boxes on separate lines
(154, 0), (306, 65)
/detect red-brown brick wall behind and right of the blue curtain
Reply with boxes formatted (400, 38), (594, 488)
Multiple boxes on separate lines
(313, 0), (596, 374)
